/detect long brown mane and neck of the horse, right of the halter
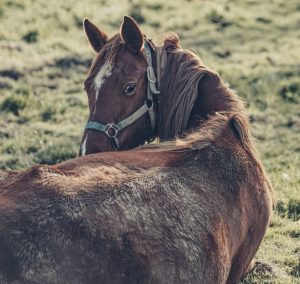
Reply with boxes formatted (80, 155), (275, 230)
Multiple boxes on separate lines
(158, 34), (246, 140)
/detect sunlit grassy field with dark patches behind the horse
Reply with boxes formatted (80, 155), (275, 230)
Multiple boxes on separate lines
(0, 0), (300, 283)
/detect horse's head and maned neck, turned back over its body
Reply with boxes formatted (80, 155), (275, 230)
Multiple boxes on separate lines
(79, 17), (248, 156)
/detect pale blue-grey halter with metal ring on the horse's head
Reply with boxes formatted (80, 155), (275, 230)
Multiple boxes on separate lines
(85, 39), (160, 151)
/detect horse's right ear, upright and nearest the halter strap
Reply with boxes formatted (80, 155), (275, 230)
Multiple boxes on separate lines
(120, 16), (144, 52)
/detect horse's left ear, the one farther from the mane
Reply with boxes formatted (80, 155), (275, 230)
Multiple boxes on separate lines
(83, 19), (108, 52)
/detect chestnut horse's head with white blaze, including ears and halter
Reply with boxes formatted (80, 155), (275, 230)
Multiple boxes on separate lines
(79, 17), (157, 155)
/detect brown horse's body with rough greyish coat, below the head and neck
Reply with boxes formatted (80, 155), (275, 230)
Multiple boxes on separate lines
(0, 115), (270, 283)
